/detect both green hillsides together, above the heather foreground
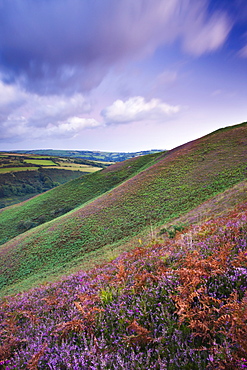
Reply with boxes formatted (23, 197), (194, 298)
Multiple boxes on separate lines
(0, 124), (247, 292)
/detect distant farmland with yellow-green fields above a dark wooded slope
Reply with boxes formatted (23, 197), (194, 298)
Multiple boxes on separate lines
(0, 152), (104, 208)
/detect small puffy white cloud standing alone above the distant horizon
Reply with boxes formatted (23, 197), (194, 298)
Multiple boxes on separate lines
(101, 96), (180, 124)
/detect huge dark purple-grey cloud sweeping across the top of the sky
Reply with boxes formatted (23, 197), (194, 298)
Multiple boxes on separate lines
(0, 0), (231, 95)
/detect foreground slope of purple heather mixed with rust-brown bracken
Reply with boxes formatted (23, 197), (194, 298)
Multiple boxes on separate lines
(0, 204), (247, 370)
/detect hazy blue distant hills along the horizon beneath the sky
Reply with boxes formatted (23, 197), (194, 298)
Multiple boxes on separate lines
(15, 149), (164, 162)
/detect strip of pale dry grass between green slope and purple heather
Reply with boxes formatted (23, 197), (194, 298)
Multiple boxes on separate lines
(0, 181), (247, 296)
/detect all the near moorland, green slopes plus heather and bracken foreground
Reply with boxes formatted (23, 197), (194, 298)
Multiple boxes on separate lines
(0, 123), (247, 370)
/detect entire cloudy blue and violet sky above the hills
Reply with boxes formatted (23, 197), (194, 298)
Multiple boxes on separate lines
(0, 0), (247, 152)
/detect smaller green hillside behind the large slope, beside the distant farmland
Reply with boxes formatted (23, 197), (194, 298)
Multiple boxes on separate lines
(0, 154), (160, 244)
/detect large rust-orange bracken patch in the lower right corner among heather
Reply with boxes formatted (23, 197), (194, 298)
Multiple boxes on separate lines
(173, 228), (247, 370)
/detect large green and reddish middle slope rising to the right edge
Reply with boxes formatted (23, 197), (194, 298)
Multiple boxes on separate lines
(0, 123), (247, 296)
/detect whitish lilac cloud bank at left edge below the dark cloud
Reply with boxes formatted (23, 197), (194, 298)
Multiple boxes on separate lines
(0, 82), (99, 142)
